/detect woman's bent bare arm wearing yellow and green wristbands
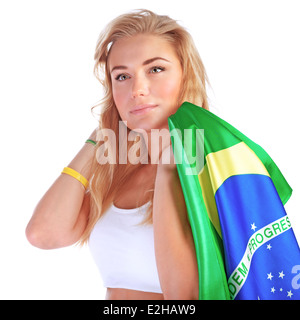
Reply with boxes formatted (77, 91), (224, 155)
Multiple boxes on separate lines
(26, 130), (96, 249)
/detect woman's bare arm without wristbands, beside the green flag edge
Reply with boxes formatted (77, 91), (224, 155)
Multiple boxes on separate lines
(153, 148), (199, 300)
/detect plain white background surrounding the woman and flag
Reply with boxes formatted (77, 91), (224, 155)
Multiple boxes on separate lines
(0, 0), (300, 299)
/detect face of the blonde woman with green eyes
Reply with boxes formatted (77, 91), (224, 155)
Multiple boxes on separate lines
(108, 34), (182, 132)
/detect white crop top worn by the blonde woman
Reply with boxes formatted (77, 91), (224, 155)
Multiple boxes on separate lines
(89, 203), (162, 293)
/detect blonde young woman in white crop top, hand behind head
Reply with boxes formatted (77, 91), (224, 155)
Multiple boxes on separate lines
(26, 10), (208, 299)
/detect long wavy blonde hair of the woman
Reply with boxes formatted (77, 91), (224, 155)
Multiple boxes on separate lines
(80, 10), (208, 244)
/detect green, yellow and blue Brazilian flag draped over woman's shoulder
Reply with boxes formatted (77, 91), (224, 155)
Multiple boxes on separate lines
(168, 102), (300, 300)
